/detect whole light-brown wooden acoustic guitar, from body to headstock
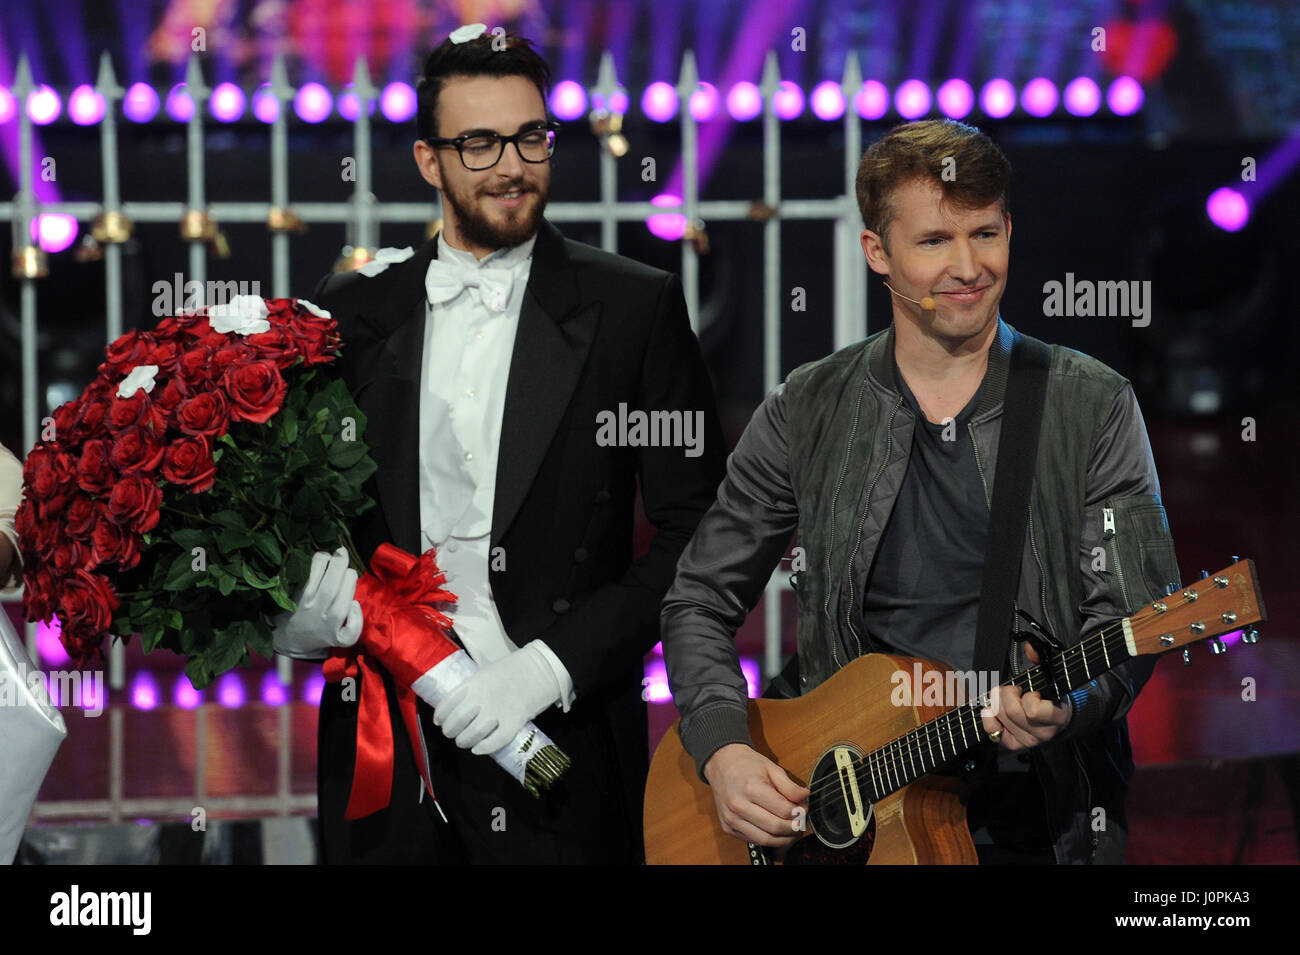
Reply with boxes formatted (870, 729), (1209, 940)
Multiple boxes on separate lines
(645, 560), (1266, 865)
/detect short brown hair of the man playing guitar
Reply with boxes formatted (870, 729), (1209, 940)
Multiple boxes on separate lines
(857, 120), (1011, 252)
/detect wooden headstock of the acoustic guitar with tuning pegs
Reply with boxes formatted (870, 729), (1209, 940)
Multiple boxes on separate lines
(1125, 559), (1268, 655)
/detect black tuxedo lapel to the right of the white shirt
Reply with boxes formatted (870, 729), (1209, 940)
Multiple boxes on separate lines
(491, 220), (601, 544)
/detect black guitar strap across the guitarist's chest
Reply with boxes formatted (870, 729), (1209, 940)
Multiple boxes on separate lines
(975, 335), (1052, 673)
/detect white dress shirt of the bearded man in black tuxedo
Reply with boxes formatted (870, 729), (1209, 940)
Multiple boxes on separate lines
(420, 234), (573, 712)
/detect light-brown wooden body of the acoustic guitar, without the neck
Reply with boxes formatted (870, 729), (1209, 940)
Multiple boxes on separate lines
(645, 654), (978, 865)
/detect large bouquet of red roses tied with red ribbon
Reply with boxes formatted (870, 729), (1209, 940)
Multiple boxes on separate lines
(16, 296), (567, 815)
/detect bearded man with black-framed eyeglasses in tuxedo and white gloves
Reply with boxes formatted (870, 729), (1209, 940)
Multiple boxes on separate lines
(304, 25), (725, 863)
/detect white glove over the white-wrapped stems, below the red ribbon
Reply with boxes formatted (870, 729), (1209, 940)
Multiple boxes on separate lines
(433, 642), (560, 756)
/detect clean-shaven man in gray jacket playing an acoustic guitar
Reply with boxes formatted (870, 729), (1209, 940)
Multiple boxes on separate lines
(647, 121), (1178, 863)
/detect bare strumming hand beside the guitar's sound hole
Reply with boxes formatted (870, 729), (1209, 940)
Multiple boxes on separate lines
(705, 743), (809, 846)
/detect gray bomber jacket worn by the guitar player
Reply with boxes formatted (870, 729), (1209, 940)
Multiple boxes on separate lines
(662, 318), (1179, 863)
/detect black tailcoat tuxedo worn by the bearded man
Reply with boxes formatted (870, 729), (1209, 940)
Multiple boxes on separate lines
(312, 221), (725, 863)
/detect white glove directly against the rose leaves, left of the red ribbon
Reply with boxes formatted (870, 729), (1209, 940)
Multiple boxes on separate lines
(270, 547), (361, 660)
